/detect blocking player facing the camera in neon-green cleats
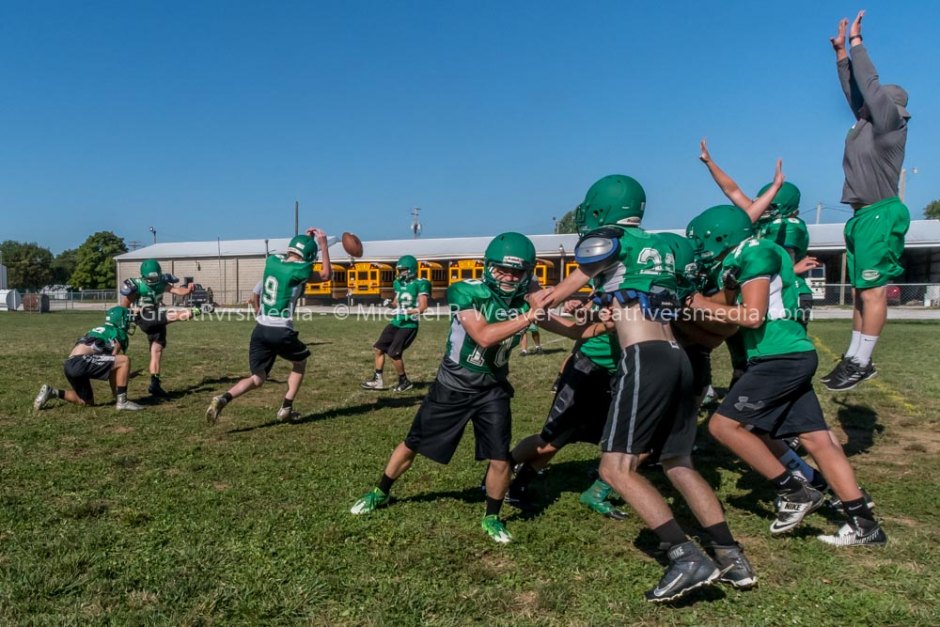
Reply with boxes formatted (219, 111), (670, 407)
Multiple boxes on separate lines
(350, 233), (564, 543)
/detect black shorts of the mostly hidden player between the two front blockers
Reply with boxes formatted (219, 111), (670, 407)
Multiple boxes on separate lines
(539, 351), (614, 448)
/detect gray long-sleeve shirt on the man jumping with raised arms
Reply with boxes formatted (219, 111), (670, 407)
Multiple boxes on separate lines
(836, 44), (907, 207)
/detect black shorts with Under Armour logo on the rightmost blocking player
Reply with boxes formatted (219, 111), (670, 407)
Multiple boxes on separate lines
(717, 351), (829, 438)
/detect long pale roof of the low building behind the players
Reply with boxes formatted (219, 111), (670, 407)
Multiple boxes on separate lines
(116, 220), (940, 263)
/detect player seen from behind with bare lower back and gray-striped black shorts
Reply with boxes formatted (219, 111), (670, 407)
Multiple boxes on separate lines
(552, 175), (756, 602)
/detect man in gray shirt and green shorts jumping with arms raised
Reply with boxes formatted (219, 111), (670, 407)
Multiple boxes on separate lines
(822, 11), (911, 392)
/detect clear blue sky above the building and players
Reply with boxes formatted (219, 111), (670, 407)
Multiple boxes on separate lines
(0, 0), (940, 252)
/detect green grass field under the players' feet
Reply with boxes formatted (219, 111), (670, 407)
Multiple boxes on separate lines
(0, 313), (940, 625)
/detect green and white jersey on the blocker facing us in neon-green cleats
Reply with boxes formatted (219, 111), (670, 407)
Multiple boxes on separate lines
(437, 279), (529, 392)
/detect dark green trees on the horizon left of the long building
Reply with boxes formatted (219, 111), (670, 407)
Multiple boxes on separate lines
(0, 231), (127, 290)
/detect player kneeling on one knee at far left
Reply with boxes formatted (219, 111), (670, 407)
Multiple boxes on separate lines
(33, 307), (143, 411)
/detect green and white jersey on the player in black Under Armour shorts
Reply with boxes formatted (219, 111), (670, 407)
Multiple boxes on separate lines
(722, 237), (815, 359)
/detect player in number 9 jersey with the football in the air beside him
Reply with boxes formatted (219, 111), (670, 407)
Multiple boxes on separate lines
(206, 228), (333, 425)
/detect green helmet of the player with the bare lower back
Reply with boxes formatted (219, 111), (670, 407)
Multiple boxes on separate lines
(574, 174), (646, 235)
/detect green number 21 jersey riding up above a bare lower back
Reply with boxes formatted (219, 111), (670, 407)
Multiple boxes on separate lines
(578, 227), (678, 294)
